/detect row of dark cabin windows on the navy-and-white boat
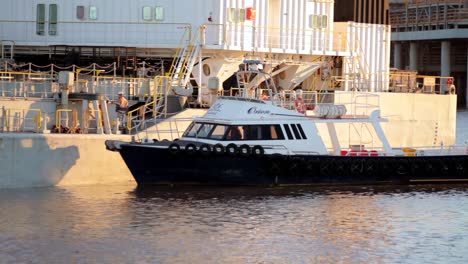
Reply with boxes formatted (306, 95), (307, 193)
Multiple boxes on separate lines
(183, 123), (307, 141)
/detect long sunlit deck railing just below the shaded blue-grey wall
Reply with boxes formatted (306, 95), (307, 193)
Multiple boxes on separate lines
(0, 63), (154, 100)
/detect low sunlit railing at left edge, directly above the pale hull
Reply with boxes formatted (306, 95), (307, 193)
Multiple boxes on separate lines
(0, 107), (43, 133)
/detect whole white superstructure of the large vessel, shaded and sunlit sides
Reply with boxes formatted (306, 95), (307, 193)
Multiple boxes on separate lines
(0, 0), (390, 96)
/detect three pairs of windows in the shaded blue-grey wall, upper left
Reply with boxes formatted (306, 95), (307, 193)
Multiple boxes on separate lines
(36, 4), (164, 36)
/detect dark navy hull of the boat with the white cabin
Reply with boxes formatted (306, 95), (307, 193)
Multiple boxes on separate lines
(120, 144), (468, 185)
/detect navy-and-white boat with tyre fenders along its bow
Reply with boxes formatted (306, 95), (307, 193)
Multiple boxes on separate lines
(106, 91), (468, 186)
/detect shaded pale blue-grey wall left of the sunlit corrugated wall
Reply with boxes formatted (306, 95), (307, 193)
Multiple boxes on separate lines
(0, 0), (220, 48)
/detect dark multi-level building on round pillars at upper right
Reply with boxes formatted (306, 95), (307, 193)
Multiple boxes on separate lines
(390, 0), (468, 108)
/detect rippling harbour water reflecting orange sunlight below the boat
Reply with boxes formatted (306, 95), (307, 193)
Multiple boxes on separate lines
(0, 112), (468, 263)
